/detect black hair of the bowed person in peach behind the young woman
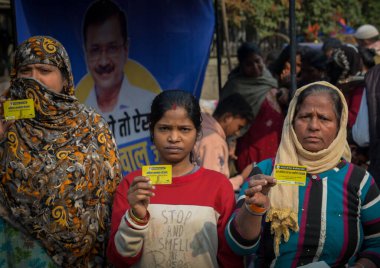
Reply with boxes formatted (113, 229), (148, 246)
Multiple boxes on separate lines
(213, 93), (253, 122)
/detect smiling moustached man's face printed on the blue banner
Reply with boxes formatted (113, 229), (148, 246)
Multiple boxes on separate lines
(86, 16), (128, 93)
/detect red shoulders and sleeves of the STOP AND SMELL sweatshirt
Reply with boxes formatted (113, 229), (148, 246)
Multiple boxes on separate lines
(107, 167), (243, 267)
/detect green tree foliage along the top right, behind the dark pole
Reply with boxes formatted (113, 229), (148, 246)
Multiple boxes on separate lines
(225, 0), (380, 41)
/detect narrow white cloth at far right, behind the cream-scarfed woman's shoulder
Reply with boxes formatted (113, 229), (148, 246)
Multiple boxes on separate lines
(352, 89), (369, 147)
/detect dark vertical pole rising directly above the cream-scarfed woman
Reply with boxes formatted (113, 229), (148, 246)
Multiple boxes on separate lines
(289, 0), (297, 97)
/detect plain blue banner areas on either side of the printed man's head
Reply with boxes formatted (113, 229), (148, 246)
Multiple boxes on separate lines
(14, 0), (215, 97)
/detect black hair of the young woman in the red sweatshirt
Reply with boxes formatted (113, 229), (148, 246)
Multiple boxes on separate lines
(149, 89), (202, 137)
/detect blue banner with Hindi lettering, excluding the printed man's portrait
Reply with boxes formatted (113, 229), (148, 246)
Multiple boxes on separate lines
(14, 0), (214, 174)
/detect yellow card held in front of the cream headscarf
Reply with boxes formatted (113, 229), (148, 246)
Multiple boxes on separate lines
(274, 164), (307, 186)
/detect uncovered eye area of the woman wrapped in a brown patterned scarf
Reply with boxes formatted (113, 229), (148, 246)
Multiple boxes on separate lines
(17, 63), (65, 93)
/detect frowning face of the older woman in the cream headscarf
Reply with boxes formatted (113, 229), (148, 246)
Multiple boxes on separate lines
(293, 92), (339, 152)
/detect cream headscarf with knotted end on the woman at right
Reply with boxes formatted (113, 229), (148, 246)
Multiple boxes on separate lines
(266, 81), (351, 256)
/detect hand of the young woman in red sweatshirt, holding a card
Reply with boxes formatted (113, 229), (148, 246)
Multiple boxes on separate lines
(127, 176), (155, 219)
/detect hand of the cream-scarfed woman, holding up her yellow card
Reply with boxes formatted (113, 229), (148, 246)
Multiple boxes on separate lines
(245, 174), (276, 208)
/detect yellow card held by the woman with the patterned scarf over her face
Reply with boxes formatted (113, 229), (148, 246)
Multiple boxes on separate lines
(4, 99), (35, 120)
